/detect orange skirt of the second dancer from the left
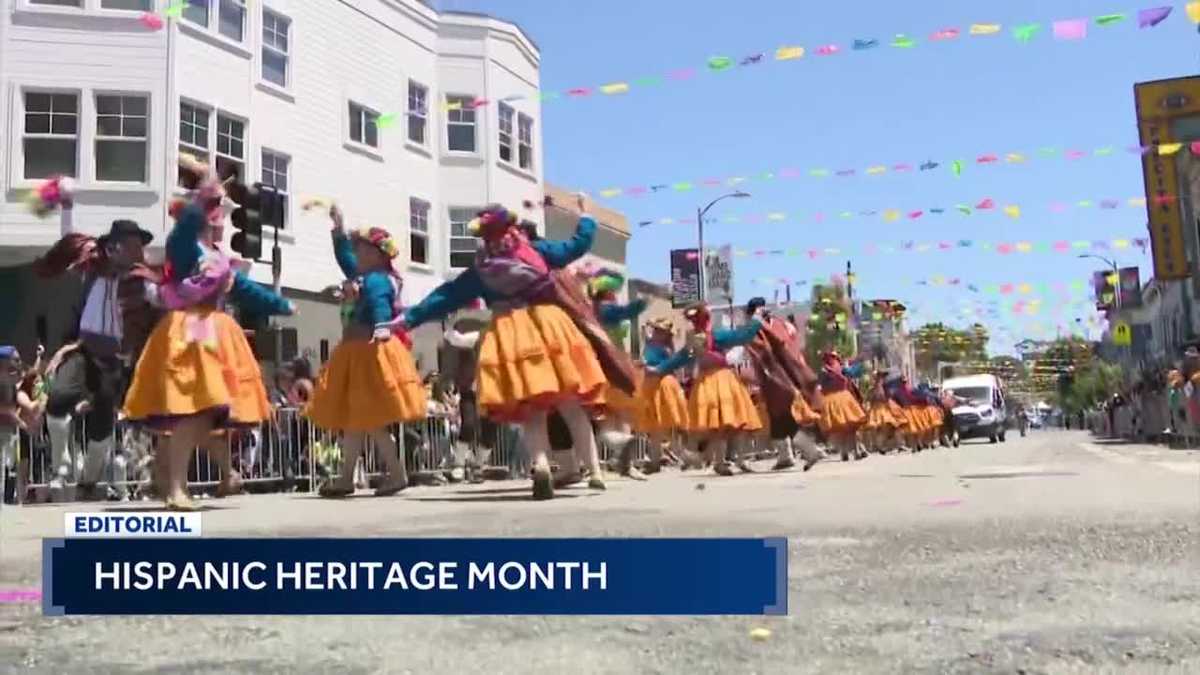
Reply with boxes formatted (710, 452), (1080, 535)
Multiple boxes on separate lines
(305, 338), (426, 431)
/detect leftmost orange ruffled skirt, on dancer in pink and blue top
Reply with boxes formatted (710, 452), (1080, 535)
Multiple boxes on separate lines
(122, 307), (271, 430)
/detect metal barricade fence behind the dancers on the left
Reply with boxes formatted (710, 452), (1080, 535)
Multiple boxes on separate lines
(10, 408), (710, 502)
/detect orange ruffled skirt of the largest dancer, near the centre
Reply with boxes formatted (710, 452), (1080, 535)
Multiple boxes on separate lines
(475, 305), (608, 422)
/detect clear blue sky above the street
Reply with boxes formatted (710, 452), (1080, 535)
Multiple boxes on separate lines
(440, 0), (1200, 345)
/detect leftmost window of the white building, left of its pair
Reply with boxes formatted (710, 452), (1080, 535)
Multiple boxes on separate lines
(22, 91), (79, 178)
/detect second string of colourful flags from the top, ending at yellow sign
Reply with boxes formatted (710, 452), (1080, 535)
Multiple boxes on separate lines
(614, 142), (1200, 199)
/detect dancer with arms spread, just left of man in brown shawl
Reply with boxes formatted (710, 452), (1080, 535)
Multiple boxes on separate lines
(676, 304), (763, 476)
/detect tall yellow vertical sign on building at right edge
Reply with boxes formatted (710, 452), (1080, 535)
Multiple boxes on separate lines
(1134, 77), (1200, 280)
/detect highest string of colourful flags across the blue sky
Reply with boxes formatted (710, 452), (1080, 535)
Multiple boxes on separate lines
(468, 2), (1200, 109)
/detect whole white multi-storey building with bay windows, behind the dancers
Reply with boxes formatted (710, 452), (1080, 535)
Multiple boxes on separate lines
(0, 0), (542, 368)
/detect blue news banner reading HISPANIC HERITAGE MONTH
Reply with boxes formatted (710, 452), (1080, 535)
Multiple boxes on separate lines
(42, 538), (787, 616)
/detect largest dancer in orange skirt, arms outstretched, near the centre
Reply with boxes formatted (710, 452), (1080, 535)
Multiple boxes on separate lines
(396, 196), (606, 500)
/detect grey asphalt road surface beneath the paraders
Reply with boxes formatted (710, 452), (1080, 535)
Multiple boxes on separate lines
(0, 431), (1200, 675)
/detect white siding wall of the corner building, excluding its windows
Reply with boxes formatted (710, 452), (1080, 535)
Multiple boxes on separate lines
(0, 0), (542, 301)
